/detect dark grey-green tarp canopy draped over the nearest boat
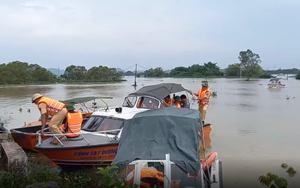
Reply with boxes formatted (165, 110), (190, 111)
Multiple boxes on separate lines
(112, 108), (201, 175)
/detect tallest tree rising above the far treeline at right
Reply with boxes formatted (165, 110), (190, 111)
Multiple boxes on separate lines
(238, 49), (261, 81)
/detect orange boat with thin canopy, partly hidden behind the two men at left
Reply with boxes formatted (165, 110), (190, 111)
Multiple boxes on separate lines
(10, 97), (112, 152)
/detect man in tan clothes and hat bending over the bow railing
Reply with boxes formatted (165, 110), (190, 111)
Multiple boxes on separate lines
(32, 93), (68, 145)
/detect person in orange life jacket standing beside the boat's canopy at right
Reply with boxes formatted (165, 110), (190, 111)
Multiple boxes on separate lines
(194, 82), (211, 125)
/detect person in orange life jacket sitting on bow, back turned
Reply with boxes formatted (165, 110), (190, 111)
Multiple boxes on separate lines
(61, 105), (83, 138)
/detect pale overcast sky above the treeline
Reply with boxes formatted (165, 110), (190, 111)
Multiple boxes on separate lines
(0, 0), (300, 69)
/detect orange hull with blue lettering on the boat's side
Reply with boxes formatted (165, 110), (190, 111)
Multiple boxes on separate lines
(38, 143), (118, 169)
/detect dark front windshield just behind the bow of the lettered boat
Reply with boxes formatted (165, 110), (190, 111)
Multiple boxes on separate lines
(82, 116), (124, 135)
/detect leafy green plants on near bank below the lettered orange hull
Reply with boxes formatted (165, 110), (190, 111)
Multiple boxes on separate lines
(0, 148), (138, 188)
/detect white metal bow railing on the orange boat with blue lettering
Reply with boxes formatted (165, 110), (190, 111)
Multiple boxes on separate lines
(36, 128), (122, 146)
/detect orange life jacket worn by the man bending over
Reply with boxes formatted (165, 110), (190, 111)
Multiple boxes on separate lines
(37, 97), (66, 116)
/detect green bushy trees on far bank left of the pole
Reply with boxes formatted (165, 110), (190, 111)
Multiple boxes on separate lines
(0, 61), (123, 84)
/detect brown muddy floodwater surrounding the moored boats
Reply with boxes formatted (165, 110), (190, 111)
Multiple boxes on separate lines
(0, 77), (300, 187)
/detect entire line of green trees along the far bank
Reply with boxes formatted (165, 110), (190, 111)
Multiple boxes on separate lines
(0, 49), (300, 84)
